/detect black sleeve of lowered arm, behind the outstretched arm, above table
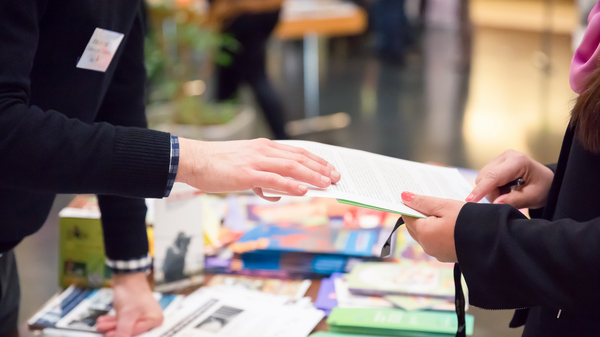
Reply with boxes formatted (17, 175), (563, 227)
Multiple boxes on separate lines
(97, 12), (148, 264)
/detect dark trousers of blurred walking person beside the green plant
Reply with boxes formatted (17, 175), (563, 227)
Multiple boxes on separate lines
(217, 11), (287, 139)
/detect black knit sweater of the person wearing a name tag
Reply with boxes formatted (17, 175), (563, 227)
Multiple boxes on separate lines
(0, 0), (170, 260)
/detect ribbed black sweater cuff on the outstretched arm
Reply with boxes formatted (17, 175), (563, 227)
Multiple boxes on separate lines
(108, 127), (171, 198)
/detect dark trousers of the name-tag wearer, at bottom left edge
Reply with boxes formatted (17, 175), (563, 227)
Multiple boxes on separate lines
(0, 249), (21, 337)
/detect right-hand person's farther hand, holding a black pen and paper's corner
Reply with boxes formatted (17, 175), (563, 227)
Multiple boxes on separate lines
(466, 150), (554, 208)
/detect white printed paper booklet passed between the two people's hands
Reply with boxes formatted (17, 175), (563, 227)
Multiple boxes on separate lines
(264, 140), (472, 218)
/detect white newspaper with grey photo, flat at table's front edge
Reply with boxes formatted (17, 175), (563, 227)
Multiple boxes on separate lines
(141, 286), (323, 337)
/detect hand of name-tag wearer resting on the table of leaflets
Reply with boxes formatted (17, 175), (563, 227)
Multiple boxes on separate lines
(97, 272), (163, 337)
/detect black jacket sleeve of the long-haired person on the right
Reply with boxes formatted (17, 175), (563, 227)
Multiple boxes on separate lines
(454, 203), (600, 311)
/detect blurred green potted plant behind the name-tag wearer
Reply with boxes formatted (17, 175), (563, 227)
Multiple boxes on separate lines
(145, 5), (239, 125)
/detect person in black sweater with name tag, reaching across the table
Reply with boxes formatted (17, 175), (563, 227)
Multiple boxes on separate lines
(0, 0), (339, 336)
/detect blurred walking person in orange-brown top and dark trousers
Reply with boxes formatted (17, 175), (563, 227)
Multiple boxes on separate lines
(209, 0), (288, 139)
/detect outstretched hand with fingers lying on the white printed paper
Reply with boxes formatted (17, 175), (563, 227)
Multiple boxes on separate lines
(176, 138), (340, 201)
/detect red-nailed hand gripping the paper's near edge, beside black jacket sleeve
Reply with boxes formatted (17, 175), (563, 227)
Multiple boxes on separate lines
(402, 192), (465, 262)
